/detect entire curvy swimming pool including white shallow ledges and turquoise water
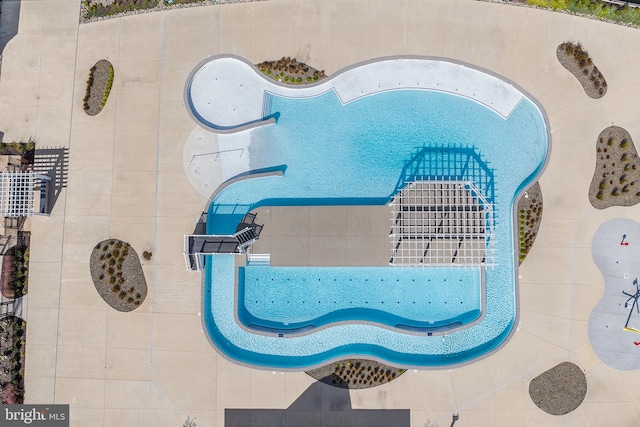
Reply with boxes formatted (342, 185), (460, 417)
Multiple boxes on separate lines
(186, 58), (549, 369)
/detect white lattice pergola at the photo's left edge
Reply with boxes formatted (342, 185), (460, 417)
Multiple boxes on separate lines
(0, 172), (51, 217)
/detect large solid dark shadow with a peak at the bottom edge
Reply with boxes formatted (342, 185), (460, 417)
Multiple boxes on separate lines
(224, 382), (410, 427)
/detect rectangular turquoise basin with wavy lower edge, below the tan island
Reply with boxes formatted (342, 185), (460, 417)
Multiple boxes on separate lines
(238, 266), (482, 333)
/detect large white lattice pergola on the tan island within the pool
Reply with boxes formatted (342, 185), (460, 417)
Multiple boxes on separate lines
(389, 180), (495, 267)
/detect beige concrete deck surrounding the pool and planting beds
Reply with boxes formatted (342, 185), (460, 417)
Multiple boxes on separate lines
(0, 0), (640, 427)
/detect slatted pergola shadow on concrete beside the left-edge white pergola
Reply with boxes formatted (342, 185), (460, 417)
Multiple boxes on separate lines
(33, 147), (69, 212)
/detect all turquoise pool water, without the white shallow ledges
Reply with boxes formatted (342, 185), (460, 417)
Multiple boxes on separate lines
(204, 82), (548, 369)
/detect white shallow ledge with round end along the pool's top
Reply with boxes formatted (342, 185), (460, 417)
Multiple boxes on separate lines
(185, 55), (524, 132)
